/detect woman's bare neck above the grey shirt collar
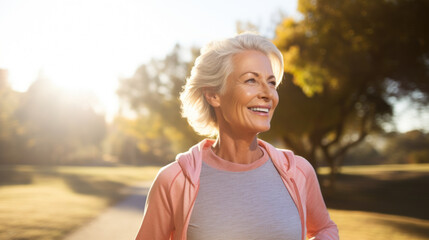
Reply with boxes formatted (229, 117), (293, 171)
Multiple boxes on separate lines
(212, 132), (263, 164)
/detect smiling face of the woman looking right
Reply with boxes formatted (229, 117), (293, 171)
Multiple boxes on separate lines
(214, 50), (279, 135)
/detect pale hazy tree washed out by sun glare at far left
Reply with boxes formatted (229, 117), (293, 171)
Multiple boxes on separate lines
(16, 77), (106, 164)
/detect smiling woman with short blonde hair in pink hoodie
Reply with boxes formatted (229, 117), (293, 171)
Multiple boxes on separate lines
(137, 33), (339, 240)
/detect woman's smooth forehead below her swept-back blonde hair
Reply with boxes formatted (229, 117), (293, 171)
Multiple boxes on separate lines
(232, 50), (273, 75)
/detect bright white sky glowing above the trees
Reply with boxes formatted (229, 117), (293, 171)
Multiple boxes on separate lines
(0, 0), (429, 131)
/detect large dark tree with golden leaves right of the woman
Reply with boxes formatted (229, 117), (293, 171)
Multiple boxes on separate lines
(270, 0), (429, 184)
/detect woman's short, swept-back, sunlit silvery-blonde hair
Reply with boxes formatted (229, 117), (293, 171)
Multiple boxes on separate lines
(180, 33), (283, 136)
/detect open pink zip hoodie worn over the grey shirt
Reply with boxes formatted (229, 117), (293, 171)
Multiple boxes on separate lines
(136, 139), (339, 240)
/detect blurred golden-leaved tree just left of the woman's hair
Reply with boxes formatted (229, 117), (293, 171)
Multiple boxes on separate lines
(117, 45), (200, 161)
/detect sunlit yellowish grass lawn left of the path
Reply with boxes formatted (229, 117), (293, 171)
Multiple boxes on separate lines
(0, 166), (159, 240)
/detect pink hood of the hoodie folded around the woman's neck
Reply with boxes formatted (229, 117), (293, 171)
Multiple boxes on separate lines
(176, 139), (296, 186)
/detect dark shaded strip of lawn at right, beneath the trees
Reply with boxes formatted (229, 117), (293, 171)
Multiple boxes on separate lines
(324, 171), (429, 220)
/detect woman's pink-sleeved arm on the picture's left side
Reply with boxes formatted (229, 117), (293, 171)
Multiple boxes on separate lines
(136, 168), (174, 240)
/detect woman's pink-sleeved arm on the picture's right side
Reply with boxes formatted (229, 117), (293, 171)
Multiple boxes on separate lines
(305, 160), (339, 240)
